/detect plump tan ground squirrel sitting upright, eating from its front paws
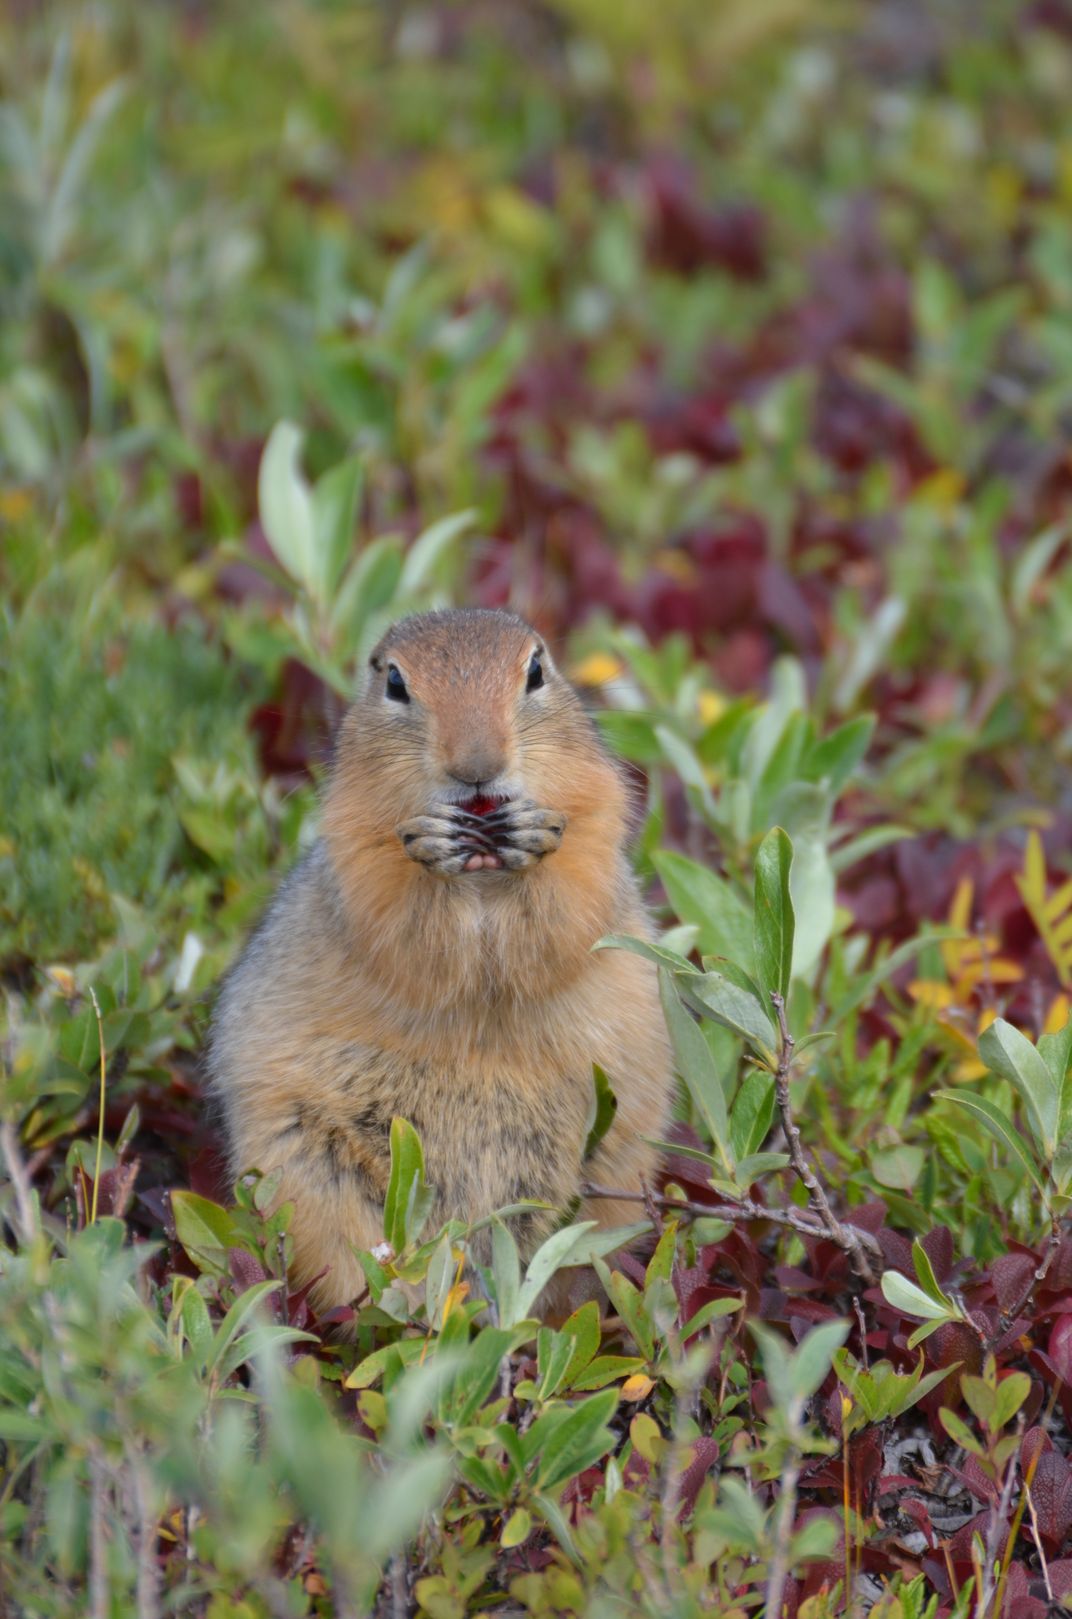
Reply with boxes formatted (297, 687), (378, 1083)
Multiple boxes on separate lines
(209, 609), (670, 1308)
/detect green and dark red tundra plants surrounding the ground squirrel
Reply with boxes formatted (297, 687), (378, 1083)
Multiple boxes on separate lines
(0, 0), (1072, 1619)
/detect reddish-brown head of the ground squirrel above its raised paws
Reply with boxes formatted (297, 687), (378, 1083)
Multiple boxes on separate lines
(331, 609), (622, 824)
